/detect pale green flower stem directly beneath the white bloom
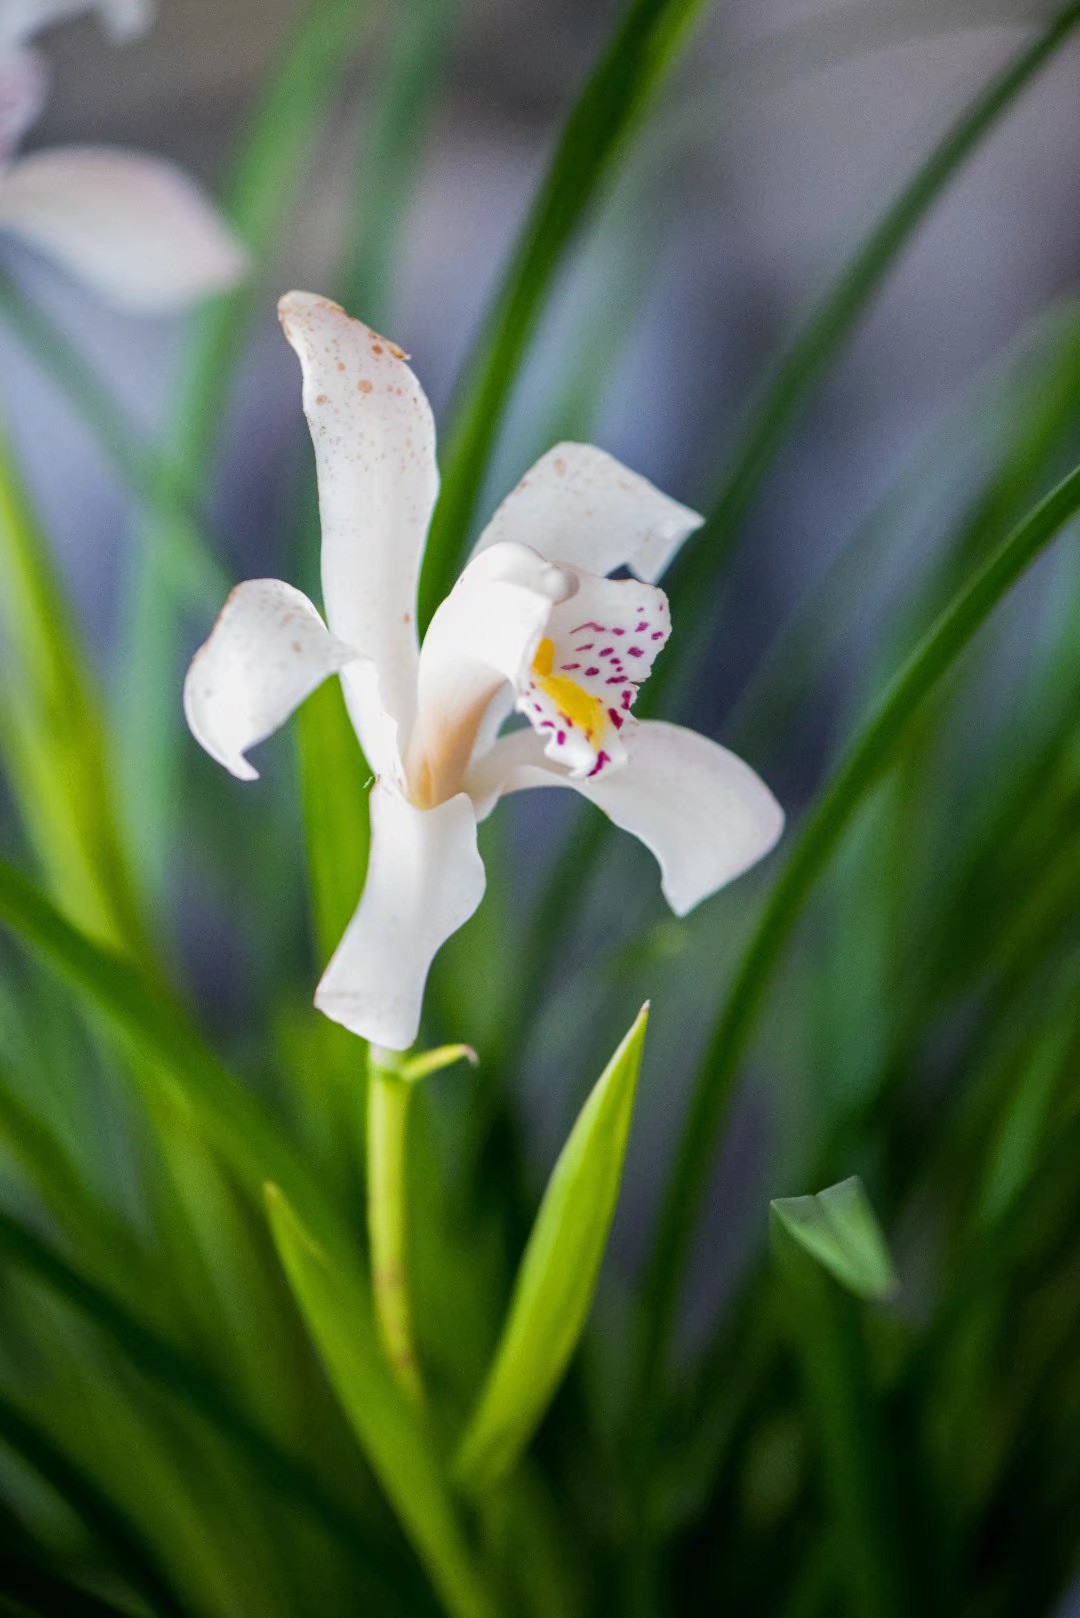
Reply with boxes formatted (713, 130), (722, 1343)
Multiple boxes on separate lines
(368, 1045), (424, 1404)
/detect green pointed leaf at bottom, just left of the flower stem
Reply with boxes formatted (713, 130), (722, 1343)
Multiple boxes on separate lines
(266, 1184), (494, 1618)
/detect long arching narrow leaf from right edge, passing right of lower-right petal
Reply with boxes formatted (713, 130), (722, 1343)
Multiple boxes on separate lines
(640, 468), (1080, 1388)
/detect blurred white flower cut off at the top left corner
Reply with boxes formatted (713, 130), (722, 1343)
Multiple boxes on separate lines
(0, 0), (246, 314)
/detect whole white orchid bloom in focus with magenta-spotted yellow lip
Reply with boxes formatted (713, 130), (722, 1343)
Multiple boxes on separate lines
(185, 293), (784, 1050)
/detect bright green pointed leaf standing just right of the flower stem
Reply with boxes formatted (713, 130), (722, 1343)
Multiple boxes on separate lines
(455, 1005), (649, 1490)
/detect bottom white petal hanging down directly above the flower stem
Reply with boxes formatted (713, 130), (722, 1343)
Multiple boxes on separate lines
(316, 778), (484, 1050)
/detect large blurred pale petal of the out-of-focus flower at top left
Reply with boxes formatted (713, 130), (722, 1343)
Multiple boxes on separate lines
(0, 146), (248, 314)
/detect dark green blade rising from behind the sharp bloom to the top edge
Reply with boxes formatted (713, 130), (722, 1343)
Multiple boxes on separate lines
(421, 0), (704, 626)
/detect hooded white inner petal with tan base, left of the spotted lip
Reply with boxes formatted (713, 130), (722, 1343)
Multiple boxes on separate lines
(406, 544), (575, 804)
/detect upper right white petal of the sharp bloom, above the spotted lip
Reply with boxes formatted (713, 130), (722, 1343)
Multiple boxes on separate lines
(476, 443), (704, 582)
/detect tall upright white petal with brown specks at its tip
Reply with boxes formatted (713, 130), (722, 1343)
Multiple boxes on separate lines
(279, 291), (439, 773)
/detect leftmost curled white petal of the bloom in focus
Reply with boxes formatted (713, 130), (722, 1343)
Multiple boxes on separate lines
(183, 579), (356, 781)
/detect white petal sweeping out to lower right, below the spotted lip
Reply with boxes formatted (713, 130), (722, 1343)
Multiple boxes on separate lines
(466, 720), (784, 916)
